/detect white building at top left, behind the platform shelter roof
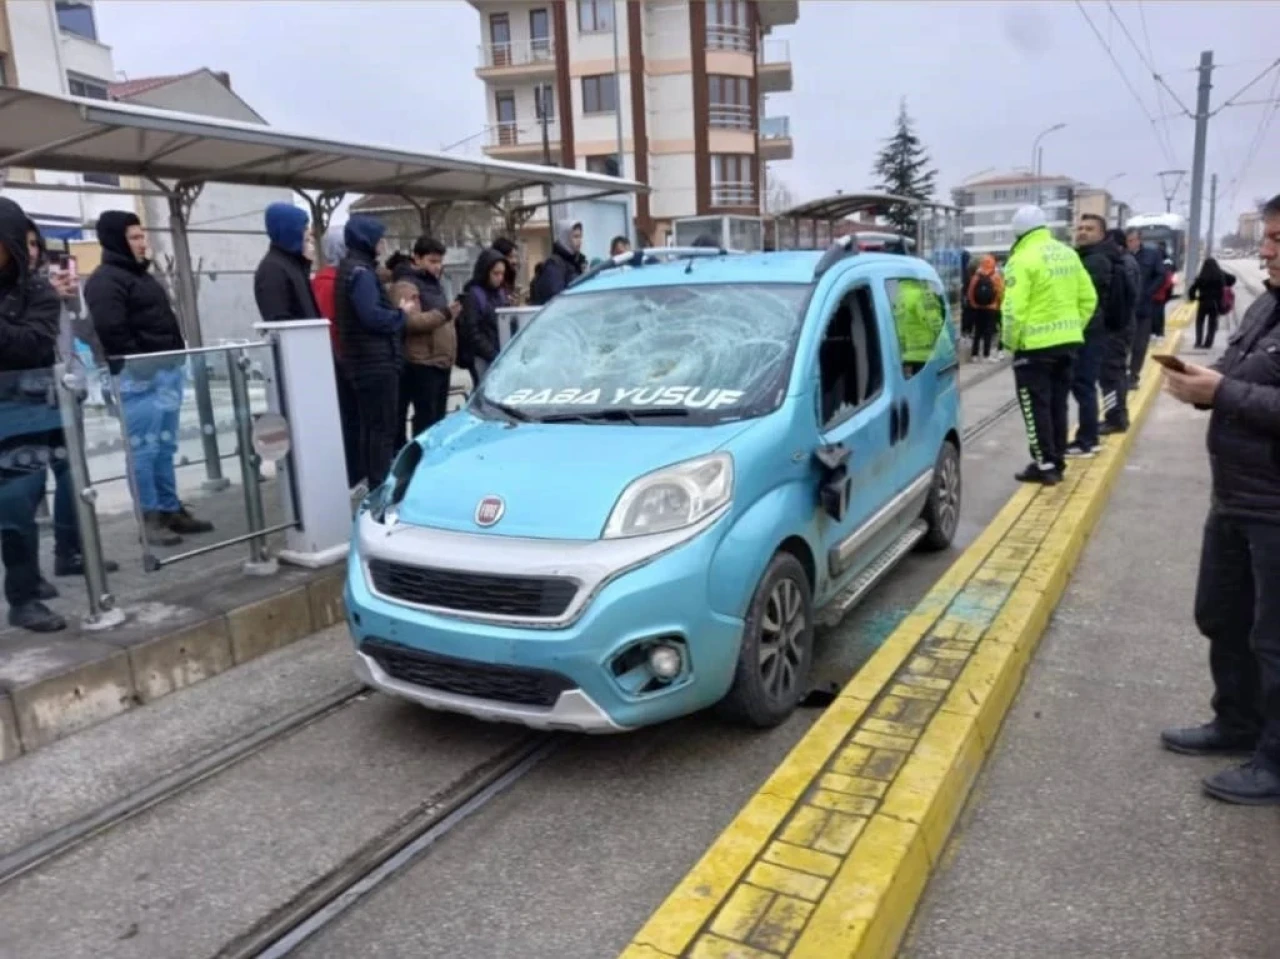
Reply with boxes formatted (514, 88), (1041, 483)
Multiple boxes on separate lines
(0, 0), (134, 252)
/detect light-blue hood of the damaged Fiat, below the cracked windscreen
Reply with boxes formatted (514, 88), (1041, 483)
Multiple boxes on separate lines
(399, 412), (749, 539)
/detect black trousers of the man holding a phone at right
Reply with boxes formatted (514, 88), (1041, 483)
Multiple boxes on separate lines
(1196, 510), (1280, 772)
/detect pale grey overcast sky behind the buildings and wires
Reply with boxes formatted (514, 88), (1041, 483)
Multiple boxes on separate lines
(97, 0), (1280, 232)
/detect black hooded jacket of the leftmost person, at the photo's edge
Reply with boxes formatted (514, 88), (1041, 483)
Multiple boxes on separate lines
(0, 197), (61, 378)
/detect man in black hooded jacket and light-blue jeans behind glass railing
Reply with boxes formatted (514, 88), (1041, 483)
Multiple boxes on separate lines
(84, 210), (214, 545)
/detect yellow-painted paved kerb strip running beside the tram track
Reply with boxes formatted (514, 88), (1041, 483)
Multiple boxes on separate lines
(622, 300), (1189, 959)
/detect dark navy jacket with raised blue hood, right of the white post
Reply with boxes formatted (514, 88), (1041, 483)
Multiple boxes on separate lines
(334, 216), (404, 376)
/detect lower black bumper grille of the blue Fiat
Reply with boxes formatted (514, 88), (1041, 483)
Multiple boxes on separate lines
(360, 638), (575, 707)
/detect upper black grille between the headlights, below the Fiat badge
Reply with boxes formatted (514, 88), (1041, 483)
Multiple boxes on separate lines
(369, 560), (577, 618)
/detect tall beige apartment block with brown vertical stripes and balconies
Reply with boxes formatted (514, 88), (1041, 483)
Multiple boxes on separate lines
(471, 0), (799, 257)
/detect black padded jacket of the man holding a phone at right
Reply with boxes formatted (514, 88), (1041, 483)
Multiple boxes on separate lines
(1208, 289), (1280, 522)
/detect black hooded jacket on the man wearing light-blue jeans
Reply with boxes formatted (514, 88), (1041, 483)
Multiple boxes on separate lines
(84, 210), (187, 375)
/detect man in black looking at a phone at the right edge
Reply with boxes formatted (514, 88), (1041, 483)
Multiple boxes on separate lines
(1157, 195), (1280, 805)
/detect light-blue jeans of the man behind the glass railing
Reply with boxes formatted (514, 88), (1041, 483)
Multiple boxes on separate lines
(120, 366), (186, 513)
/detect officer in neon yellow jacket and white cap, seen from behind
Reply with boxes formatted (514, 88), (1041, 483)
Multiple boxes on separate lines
(1001, 206), (1098, 487)
